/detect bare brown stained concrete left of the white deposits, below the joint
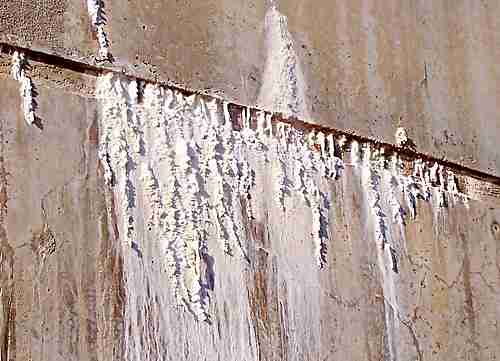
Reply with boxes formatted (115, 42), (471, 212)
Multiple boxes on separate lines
(0, 78), (122, 360)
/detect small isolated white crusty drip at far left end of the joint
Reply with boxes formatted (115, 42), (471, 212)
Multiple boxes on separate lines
(11, 51), (36, 125)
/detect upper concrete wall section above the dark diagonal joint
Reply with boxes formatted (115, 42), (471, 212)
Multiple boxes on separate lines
(0, 0), (500, 175)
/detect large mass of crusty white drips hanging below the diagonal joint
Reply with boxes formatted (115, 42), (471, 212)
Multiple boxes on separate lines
(96, 74), (467, 354)
